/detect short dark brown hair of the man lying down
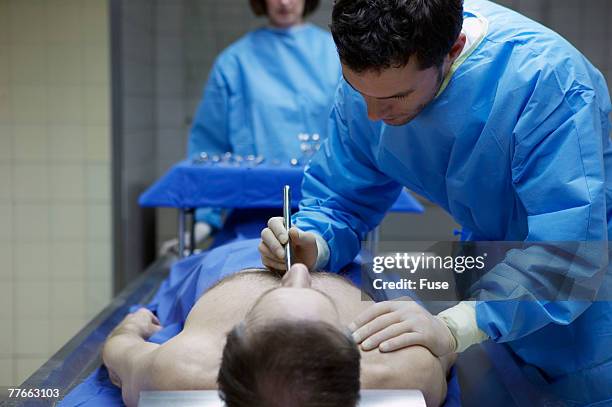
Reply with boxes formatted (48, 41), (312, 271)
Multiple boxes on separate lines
(217, 321), (360, 407)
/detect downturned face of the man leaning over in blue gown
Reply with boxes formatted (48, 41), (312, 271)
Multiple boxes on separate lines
(342, 58), (444, 126)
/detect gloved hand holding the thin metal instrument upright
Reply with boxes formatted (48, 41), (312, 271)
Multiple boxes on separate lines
(259, 216), (318, 271)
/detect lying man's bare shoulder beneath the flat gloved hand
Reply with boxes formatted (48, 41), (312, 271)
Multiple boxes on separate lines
(361, 346), (447, 406)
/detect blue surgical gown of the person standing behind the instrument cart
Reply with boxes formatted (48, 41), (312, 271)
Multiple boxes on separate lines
(188, 24), (341, 228)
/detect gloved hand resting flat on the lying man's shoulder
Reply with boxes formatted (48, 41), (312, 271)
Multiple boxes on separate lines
(349, 299), (457, 357)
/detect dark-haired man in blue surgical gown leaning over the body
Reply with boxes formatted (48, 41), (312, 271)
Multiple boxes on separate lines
(260, 0), (612, 405)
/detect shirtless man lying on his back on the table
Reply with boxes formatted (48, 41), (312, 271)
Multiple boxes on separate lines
(103, 264), (451, 407)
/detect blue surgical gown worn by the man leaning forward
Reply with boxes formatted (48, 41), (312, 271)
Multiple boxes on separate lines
(294, 0), (612, 405)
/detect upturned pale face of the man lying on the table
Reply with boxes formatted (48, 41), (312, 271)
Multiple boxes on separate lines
(245, 264), (340, 327)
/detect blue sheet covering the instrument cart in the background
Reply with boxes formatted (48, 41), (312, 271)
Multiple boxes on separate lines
(139, 160), (423, 213)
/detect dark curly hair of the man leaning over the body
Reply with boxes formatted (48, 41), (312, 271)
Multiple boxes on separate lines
(330, 0), (463, 73)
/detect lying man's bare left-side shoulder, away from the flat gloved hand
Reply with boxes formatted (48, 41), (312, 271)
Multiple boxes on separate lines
(147, 332), (220, 390)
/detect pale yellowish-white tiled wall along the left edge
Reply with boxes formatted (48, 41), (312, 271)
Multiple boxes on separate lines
(0, 0), (111, 387)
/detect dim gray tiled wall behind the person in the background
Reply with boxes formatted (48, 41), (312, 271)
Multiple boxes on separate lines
(113, 0), (612, 286)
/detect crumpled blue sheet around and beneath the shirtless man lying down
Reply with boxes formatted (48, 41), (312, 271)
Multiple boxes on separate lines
(59, 239), (461, 407)
